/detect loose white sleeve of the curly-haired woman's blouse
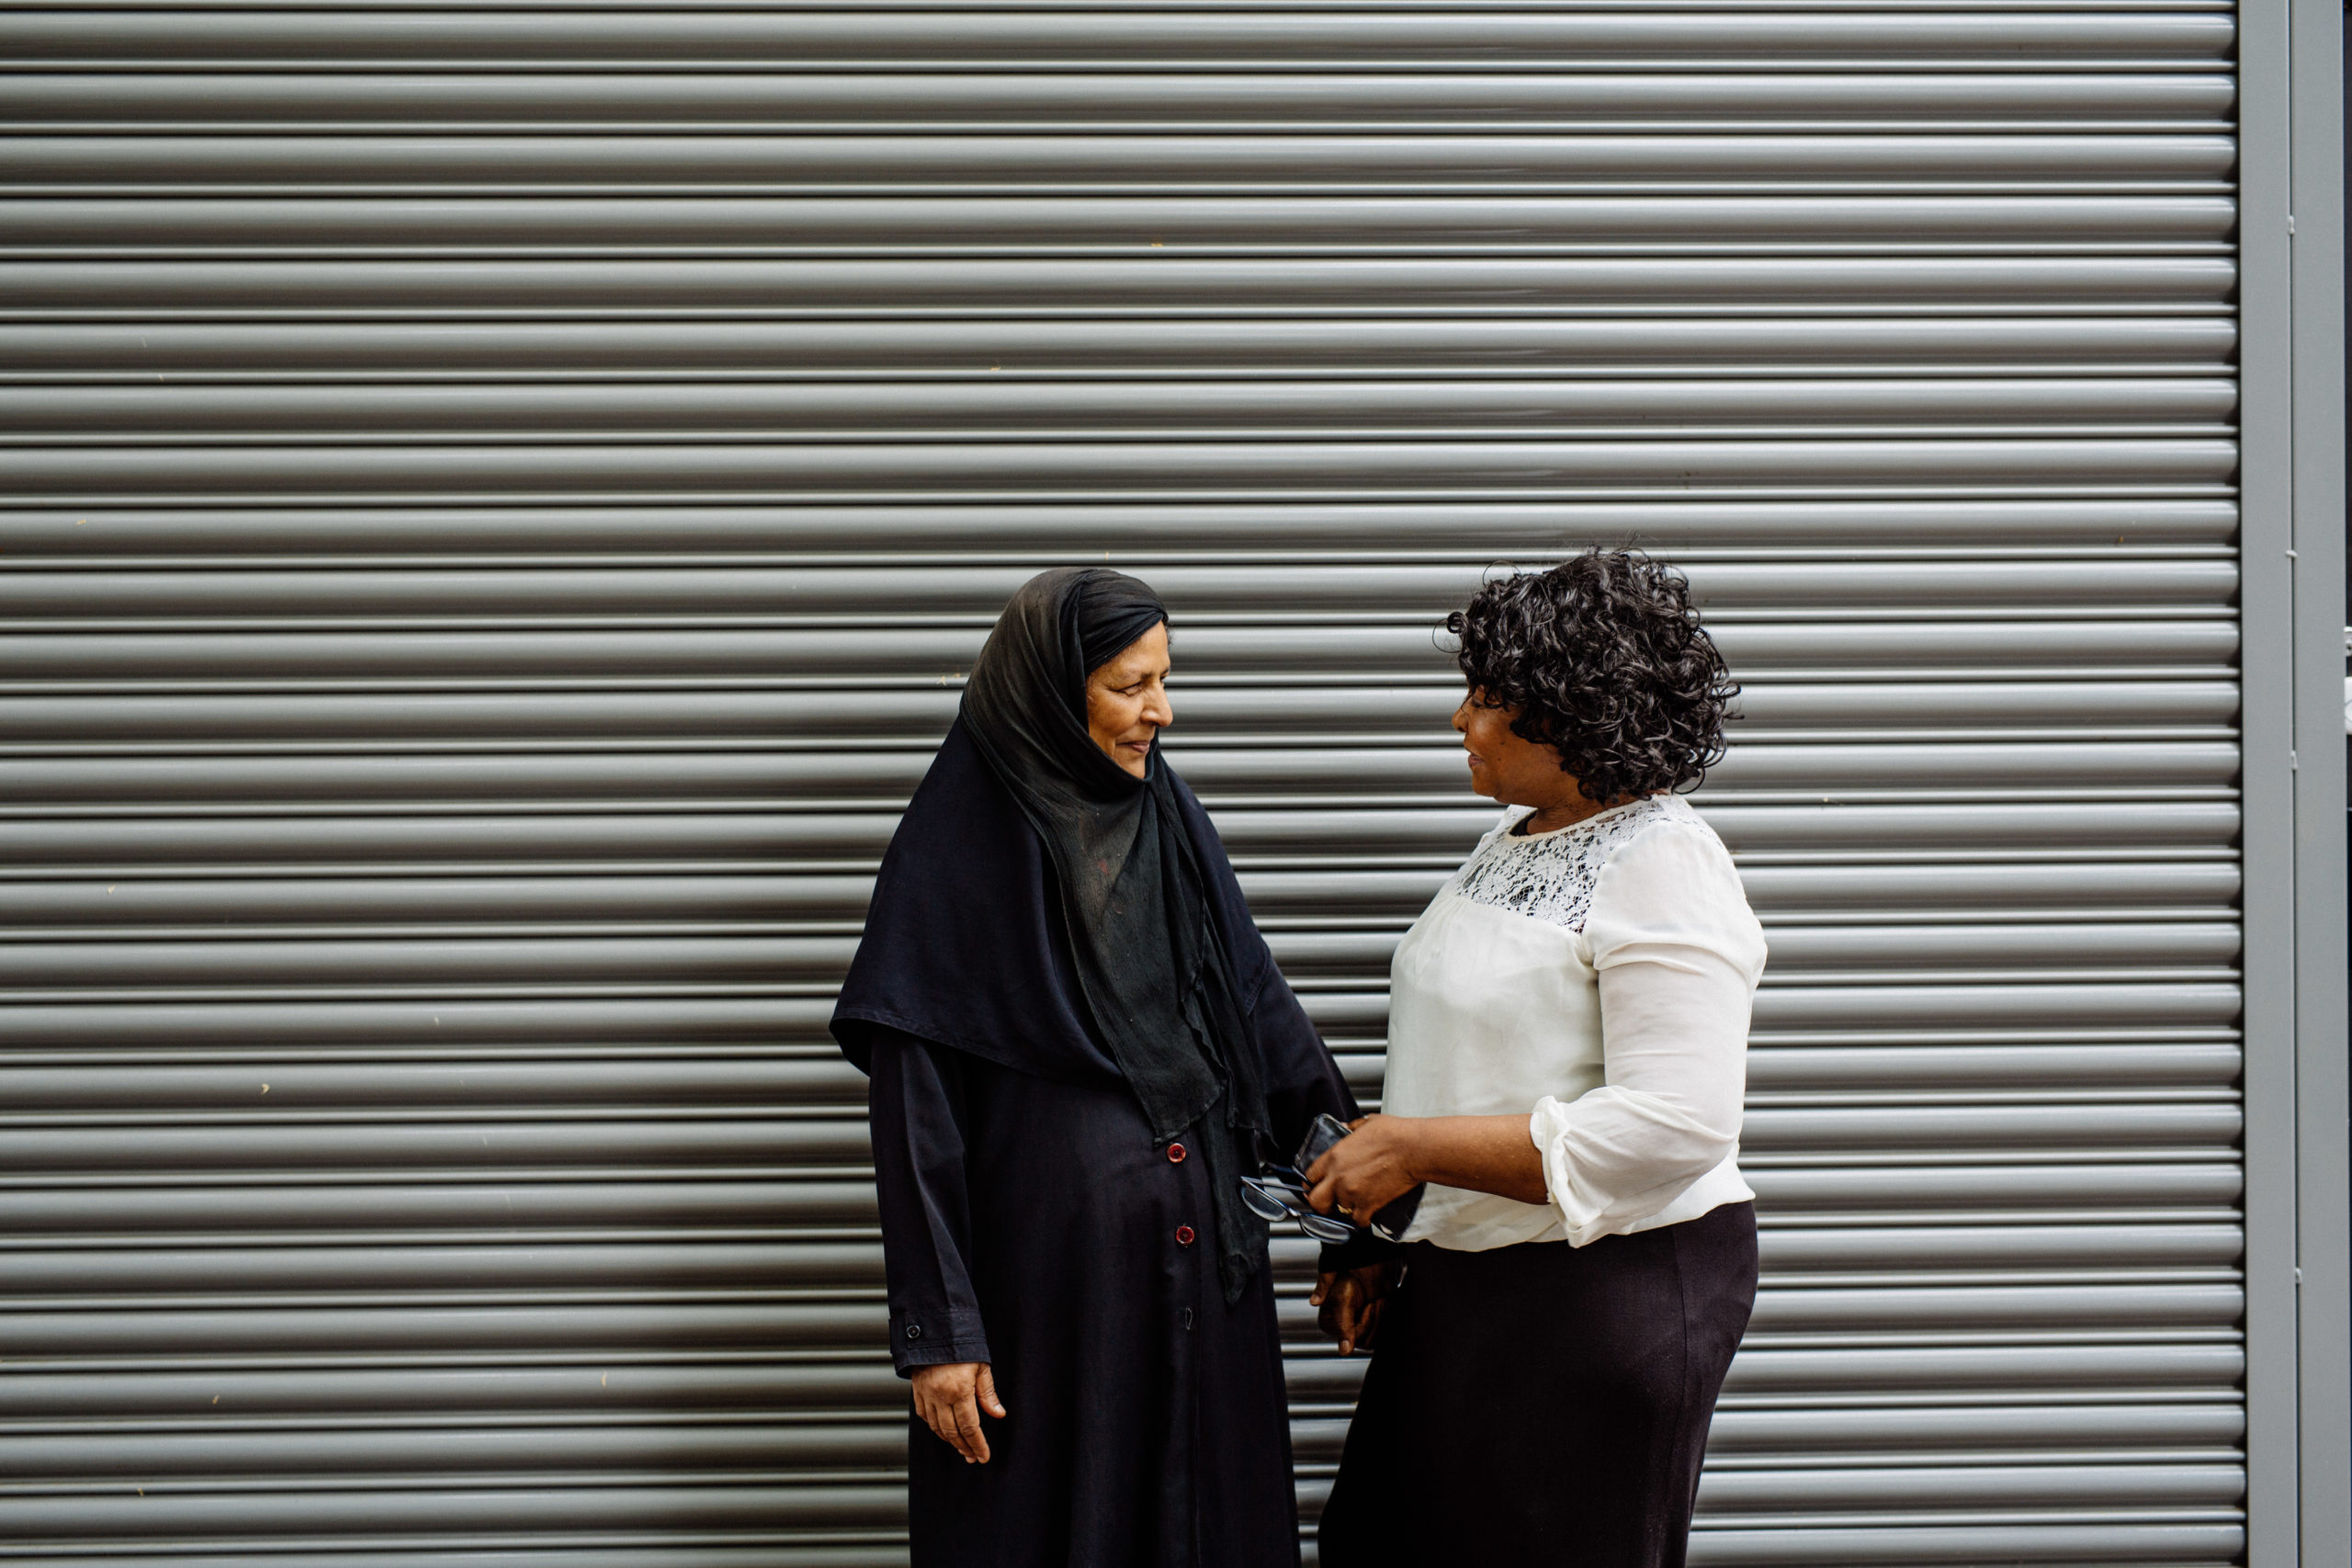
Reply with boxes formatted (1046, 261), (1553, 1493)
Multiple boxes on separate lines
(1529, 823), (1764, 1246)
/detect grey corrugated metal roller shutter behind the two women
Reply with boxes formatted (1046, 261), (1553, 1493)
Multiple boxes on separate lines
(0, 0), (2244, 1568)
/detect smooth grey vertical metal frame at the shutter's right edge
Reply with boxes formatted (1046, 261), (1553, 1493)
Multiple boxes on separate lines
(2239, 0), (2352, 1568)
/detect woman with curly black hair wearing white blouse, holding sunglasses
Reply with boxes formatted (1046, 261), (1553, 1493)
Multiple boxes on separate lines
(1307, 550), (1764, 1568)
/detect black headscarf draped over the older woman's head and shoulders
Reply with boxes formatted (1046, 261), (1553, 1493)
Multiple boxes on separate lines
(832, 567), (1268, 1303)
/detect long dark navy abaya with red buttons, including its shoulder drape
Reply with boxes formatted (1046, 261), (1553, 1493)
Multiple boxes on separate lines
(832, 597), (1357, 1568)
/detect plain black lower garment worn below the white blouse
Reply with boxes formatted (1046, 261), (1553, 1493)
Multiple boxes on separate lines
(1319, 1203), (1757, 1568)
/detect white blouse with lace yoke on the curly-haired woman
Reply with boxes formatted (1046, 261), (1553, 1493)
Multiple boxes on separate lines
(1383, 795), (1764, 1253)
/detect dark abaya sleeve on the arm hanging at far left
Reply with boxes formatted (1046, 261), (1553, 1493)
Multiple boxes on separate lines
(865, 1030), (990, 1378)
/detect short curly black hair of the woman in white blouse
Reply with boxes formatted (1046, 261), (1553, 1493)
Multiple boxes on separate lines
(1446, 547), (1740, 804)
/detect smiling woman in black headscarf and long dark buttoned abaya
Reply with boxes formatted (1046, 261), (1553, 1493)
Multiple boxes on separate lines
(832, 569), (1357, 1568)
